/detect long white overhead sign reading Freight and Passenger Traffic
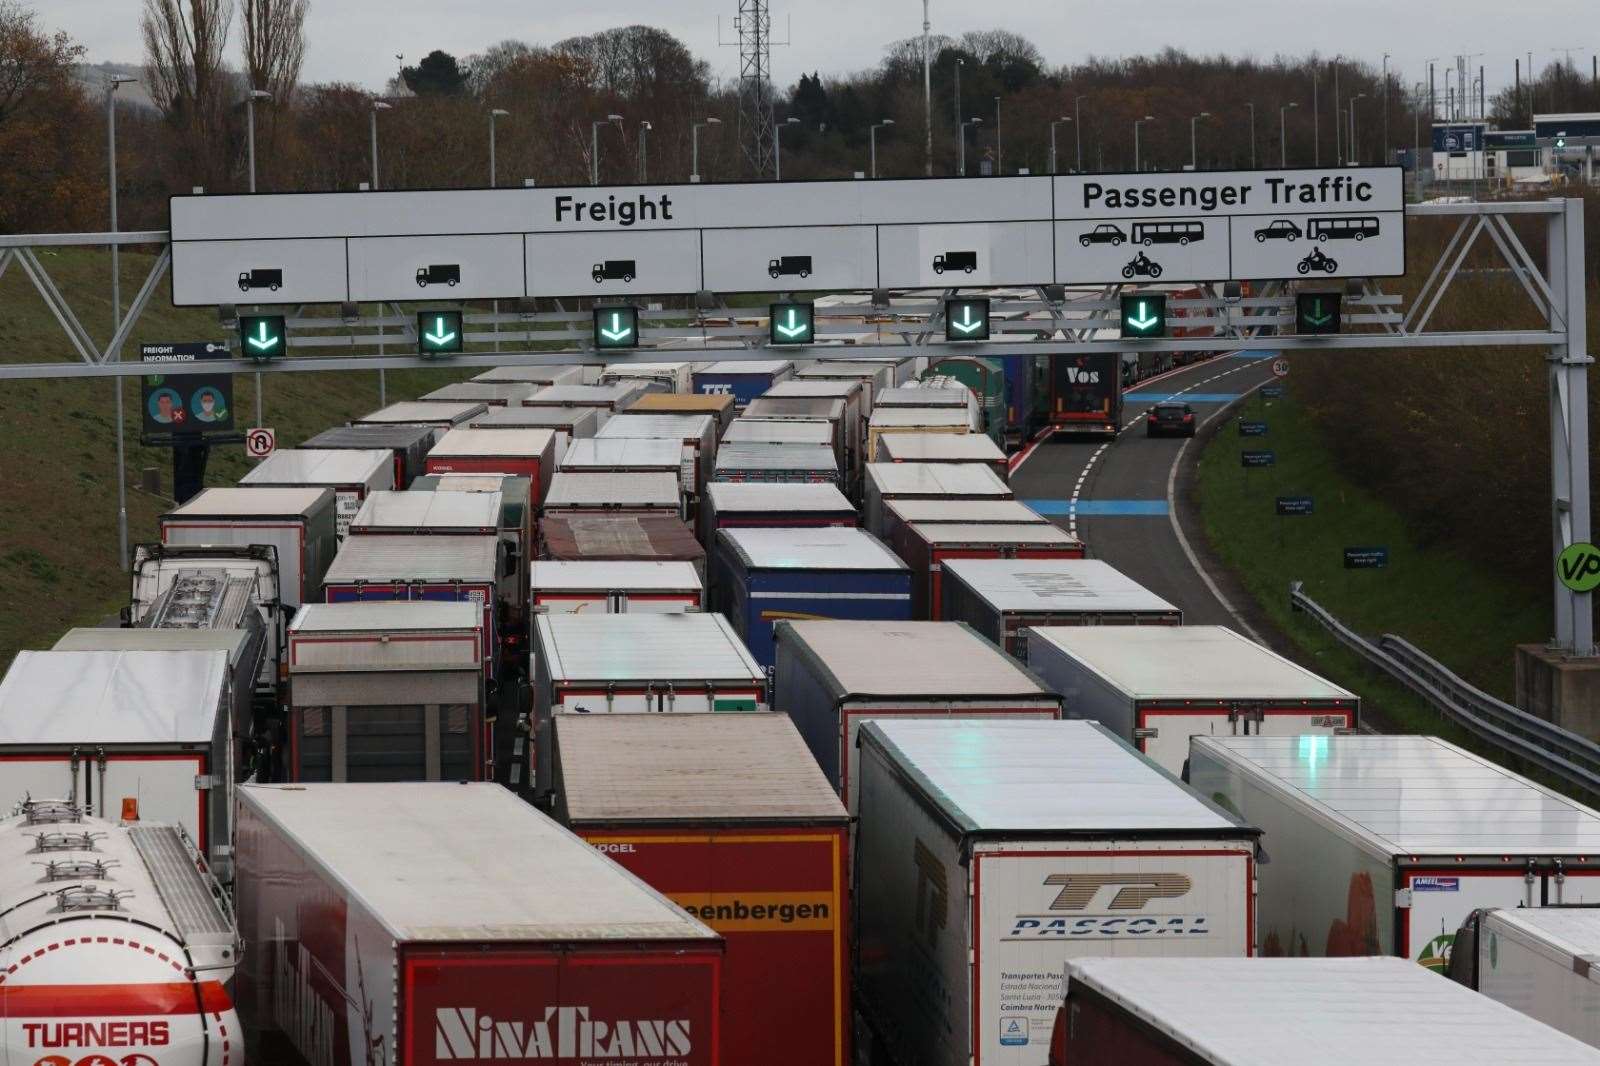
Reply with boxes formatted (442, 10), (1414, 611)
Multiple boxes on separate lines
(170, 166), (1405, 306)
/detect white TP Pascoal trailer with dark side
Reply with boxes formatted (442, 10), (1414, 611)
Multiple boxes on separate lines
(851, 719), (1259, 1066)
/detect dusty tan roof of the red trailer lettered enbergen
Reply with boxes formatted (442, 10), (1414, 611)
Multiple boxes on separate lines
(555, 712), (850, 826)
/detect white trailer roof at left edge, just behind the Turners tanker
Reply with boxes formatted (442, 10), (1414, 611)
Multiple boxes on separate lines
(0, 651), (229, 739)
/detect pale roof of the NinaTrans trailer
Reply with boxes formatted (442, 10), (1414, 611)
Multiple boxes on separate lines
(240, 781), (717, 941)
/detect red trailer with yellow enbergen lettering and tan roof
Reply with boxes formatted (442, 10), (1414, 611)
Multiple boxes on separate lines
(555, 714), (850, 1066)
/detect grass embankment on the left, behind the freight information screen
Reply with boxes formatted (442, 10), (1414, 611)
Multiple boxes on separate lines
(0, 248), (475, 671)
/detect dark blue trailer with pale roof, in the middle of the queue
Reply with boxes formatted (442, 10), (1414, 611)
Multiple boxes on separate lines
(712, 527), (910, 667)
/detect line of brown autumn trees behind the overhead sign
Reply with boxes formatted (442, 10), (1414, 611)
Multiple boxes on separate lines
(0, 0), (1600, 232)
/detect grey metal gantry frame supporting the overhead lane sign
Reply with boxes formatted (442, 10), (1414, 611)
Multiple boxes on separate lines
(0, 198), (1595, 646)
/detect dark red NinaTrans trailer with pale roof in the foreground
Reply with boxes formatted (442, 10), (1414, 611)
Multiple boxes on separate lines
(237, 781), (723, 1066)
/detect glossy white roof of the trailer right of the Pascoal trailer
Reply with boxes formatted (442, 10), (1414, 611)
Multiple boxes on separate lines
(1190, 735), (1600, 856)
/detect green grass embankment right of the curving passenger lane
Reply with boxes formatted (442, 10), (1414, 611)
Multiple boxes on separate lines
(1198, 382), (1549, 738)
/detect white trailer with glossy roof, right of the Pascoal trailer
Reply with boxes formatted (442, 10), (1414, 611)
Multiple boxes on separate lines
(1189, 735), (1600, 970)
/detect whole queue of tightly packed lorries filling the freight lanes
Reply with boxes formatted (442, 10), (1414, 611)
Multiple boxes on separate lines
(0, 350), (1600, 1066)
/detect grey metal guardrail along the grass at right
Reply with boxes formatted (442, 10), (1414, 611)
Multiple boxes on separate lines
(1290, 581), (1600, 797)
